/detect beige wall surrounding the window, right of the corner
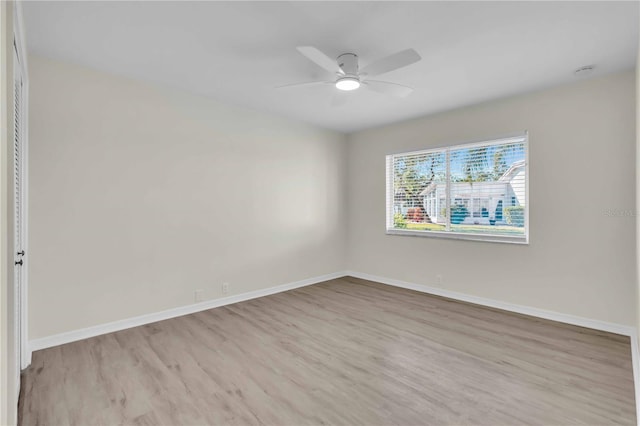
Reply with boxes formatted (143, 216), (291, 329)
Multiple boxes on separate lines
(348, 72), (636, 325)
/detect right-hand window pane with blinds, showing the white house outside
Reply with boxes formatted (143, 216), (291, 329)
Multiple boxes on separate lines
(450, 142), (526, 236)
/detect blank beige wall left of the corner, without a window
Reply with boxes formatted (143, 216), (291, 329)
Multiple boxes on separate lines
(29, 56), (346, 339)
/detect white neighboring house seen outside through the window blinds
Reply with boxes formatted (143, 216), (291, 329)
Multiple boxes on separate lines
(420, 160), (526, 225)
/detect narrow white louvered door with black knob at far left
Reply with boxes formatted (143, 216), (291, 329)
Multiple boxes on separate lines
(13, 38), (27, 374)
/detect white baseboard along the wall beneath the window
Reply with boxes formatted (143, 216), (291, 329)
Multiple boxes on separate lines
(346, 271), (636, 337)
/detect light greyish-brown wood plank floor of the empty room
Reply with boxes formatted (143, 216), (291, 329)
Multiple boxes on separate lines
(19, 278), (636, 425)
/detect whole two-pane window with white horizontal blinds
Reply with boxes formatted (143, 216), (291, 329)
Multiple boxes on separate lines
(387, 134), (528, 243)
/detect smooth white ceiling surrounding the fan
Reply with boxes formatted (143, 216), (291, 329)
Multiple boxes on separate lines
(24, 1), (639, 132)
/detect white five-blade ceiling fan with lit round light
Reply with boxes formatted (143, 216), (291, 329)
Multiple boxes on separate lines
(278, 46), (422, 105)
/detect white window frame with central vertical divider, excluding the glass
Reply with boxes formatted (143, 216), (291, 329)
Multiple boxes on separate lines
(385, 131), (530, 245)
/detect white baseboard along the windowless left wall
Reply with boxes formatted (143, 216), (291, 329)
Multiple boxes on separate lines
(28, 272), (347, 359)
